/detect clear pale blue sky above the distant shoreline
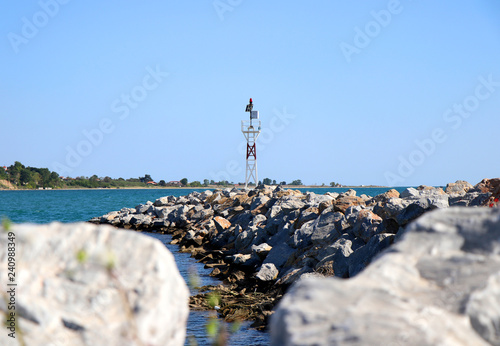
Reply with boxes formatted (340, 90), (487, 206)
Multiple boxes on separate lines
(0, 0), (500, 186)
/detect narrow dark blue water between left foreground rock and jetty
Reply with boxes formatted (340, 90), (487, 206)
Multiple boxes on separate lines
(144, 232), (269, 346)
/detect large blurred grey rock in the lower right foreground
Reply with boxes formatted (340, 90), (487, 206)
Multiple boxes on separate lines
(271, 207), (500, 346)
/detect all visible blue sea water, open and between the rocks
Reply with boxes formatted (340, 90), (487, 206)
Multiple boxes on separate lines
(0, 187), (406, 345)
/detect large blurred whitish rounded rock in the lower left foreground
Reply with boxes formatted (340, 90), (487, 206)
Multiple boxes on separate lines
(0, 223), (189, 345)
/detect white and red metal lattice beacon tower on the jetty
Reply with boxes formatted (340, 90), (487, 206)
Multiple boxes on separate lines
(241, 99), (261, 187)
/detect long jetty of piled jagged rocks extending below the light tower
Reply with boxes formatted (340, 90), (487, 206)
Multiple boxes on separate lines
(91, 179), (500, 334)
